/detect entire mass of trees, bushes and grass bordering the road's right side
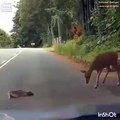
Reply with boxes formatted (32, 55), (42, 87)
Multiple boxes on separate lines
(12, 0), (120, 64)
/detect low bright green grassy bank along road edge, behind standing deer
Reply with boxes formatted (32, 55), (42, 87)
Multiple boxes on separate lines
(52, 36), (120, 64)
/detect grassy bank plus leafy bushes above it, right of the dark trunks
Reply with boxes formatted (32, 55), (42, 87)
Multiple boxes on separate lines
(51, 0), (120, 64)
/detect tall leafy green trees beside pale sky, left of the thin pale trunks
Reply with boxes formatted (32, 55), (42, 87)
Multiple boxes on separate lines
(13, 0), (50, 46)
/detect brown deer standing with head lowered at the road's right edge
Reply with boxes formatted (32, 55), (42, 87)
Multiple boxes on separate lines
(81, 52), (120, 88)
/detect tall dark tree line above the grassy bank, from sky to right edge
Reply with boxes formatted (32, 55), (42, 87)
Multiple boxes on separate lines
(12, 0), (120, 47)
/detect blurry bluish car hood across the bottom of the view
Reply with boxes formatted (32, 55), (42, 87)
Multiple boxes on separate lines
(0, 104), (120, 120)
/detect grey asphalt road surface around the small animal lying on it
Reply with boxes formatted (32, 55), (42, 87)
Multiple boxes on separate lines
(0, 48), (120, 120)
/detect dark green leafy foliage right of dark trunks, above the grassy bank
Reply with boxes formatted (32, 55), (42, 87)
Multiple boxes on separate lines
(90, 2), (120, 40)
